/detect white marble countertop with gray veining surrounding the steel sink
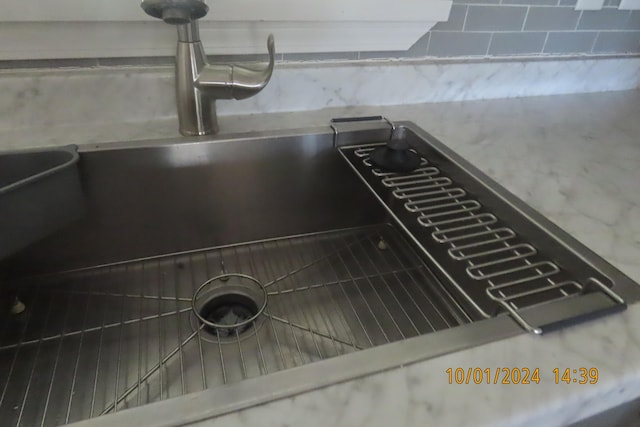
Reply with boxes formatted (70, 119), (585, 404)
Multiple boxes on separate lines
(5, 91), (640, 427)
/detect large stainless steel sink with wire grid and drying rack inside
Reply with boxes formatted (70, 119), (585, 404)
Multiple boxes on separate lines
(0, 120), (640, 426)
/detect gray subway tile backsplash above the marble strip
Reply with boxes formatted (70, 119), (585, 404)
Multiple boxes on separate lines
(0, 0), (640, 69)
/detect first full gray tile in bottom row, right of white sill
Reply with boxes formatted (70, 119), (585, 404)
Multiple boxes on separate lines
(427, 31), (491, 56)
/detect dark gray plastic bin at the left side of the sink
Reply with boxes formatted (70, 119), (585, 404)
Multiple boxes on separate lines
(0, 146), (82, 259)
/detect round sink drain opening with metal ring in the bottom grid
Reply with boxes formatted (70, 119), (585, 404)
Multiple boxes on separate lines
(191, 273), (267, 340)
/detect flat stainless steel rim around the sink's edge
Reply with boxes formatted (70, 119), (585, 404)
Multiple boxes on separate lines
(28, 121), (637, 426)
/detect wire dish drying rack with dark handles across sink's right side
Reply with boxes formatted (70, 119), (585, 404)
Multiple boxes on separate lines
(332, 117), (626, 334)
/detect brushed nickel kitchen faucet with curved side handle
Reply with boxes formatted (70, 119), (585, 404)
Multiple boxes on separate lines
(141, 0), (275, 136)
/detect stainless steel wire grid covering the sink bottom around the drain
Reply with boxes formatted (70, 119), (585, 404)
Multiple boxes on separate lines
(0, 225), (469, 426)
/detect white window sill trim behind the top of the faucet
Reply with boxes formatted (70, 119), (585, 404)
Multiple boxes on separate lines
(0, 0), (452, 59)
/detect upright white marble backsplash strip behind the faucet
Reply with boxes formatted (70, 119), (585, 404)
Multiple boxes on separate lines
(0, 57), (640, 140)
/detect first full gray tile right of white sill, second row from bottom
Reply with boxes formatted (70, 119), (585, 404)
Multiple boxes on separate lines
(464, 6), (527, 31)
